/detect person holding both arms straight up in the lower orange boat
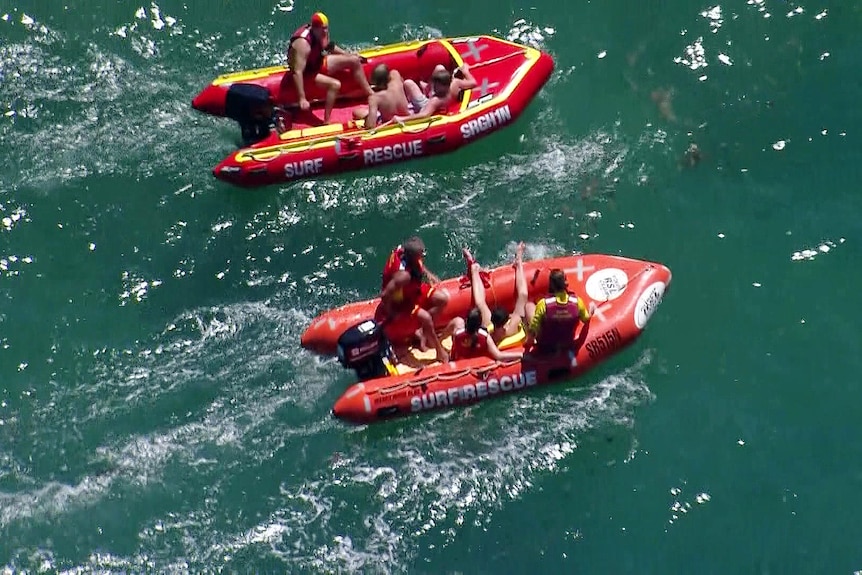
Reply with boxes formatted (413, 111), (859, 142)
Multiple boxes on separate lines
(463, 242), (528, 345)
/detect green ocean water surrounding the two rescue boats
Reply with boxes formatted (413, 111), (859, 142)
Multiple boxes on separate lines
(0, 0), (862, 574)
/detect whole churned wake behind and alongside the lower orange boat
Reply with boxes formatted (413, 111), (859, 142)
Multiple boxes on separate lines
(0, 322), (650, 572)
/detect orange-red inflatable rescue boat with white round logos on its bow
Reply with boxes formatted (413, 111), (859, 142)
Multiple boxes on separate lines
(302, 255), (671, 423)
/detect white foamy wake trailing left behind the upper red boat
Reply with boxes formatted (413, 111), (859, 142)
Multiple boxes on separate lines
(0, 34), (201, 188)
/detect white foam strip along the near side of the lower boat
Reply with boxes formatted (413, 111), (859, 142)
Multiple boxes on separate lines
(177, 354), (651, 572)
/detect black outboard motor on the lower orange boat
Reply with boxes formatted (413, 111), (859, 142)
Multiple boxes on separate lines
(338, 319), (395, 381)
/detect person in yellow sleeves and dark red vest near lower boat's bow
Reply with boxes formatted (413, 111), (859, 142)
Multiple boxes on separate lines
(524, 269), (596, 355)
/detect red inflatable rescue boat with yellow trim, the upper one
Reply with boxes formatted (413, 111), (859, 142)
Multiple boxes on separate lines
(192, 36), (554, 187)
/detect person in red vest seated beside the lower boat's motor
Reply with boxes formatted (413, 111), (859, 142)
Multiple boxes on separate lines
(374, 236), (449, 362)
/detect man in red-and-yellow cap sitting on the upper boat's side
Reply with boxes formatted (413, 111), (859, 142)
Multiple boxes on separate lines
(287, 12), (373, 124)
